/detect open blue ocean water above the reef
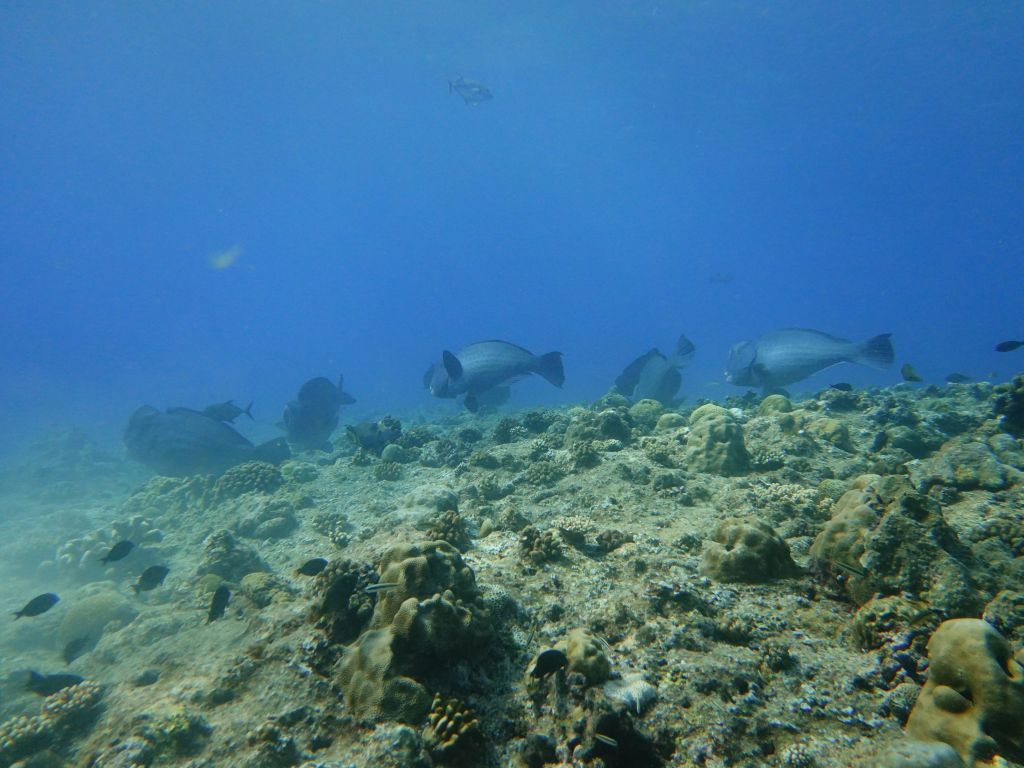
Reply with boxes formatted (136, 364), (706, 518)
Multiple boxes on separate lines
(0, 0), (1024, 451)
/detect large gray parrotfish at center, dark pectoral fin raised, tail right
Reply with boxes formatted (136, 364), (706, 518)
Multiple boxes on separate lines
(423, 341), (565, 412)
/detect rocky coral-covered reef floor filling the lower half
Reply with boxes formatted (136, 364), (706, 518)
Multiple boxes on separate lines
(9, 377), (1024, 768)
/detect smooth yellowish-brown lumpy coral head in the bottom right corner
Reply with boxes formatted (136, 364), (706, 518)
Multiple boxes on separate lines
(906, 618), (1024, 768)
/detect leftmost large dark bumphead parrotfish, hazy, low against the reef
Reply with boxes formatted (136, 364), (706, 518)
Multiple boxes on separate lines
(124, 406), (291, 477)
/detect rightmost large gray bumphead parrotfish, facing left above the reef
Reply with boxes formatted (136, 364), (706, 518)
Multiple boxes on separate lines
(725, 328), (894, 389)
